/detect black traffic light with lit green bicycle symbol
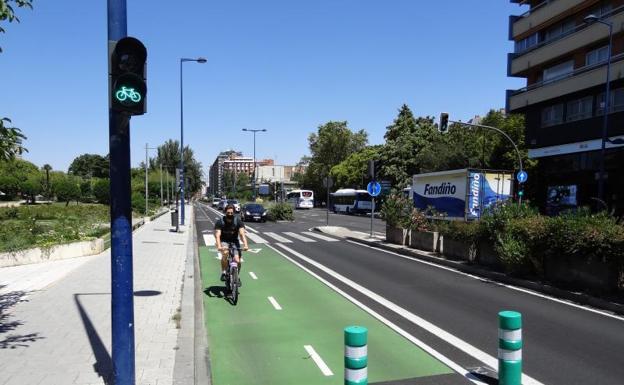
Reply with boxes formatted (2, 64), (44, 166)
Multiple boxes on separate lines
(109, 37), (147, 115)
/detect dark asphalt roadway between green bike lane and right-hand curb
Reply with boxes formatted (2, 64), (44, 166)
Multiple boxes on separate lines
(195, 202), (624, 385)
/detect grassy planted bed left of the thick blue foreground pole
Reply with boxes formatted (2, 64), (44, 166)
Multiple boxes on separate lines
(0, 203), (110, 252)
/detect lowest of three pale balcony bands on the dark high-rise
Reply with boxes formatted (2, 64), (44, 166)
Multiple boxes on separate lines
(507, 54), (624, 112)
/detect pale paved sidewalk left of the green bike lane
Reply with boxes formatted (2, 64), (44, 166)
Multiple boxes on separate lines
(0, 206), (194, 385)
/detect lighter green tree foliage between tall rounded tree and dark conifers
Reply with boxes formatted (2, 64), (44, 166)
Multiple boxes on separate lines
(331, 145), (382, 188)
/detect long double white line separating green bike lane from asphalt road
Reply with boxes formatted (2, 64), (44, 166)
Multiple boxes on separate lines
(269, 243), (543, 385)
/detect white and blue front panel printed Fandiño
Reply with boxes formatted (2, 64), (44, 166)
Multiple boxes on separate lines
(412, 170), (466, 219)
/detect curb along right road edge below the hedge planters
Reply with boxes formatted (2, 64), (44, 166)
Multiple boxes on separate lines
(346, 236), (624, 314)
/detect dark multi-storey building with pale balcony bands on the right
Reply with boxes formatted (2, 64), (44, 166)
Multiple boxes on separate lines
(506, 0), (624, 212)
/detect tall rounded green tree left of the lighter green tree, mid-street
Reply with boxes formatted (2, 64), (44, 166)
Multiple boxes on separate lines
(303, 121), (368, 197)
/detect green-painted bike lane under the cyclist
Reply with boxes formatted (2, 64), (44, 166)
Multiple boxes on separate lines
(199, 244), (454, 385)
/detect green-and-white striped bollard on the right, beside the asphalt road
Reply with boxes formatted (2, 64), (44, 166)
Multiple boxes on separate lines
(498, 310), (522, 385)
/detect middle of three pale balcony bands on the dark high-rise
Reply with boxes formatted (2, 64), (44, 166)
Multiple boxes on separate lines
(509, 7), (624, 76)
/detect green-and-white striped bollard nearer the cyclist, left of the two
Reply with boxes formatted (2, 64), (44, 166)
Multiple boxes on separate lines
(344, 326), (368, 385)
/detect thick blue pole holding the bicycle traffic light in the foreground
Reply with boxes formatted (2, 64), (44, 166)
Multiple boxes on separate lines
(108, 0), (135, 385)
